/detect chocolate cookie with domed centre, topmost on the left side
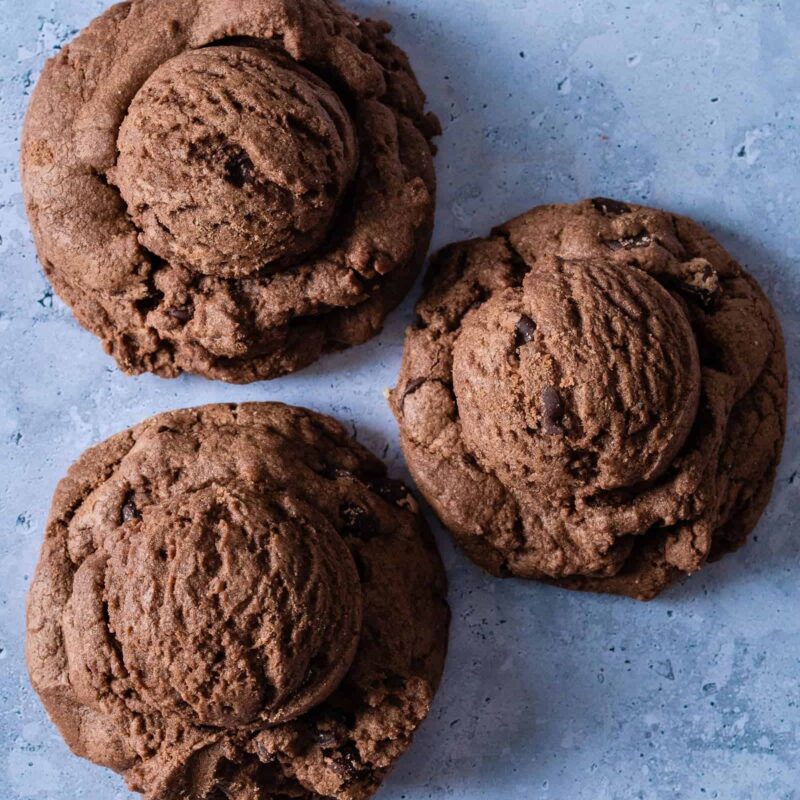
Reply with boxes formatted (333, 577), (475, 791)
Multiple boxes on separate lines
(22, 0), (440, 383)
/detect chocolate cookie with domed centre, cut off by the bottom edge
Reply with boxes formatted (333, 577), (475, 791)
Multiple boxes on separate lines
(27, 403), (449, 800)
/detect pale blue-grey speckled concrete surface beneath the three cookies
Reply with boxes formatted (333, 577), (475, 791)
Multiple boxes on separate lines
(0, 0), (800, 800)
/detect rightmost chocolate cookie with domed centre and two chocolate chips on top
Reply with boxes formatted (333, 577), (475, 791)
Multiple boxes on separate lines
(391, 198), (787, 599)
